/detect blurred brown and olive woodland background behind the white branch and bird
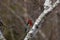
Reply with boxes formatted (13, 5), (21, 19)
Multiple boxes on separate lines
(0, 0), (60, 40)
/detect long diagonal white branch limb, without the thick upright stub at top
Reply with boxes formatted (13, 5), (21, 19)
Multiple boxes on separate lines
(24, 0), (60, 40)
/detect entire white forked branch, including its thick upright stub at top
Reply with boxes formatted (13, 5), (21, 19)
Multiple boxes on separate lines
(24, 0), (60, 40)
